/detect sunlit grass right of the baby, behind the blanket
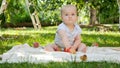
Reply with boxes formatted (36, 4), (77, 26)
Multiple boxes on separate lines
(82, 31), (120, 47)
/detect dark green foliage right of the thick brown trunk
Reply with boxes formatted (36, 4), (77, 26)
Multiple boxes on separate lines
(88, 0), (119, 24)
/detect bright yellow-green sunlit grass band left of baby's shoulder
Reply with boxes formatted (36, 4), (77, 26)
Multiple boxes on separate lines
(1, 26), (57, 35)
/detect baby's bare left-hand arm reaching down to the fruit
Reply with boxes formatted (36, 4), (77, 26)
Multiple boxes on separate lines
(58, 30), (71, 49)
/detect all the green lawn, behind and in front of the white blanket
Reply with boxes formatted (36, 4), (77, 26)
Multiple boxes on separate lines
(0, 26), (120, 68)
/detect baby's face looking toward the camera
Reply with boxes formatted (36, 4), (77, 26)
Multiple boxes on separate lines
(61, 7), (78, 24)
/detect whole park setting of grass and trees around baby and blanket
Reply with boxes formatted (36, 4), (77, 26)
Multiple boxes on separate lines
(0, 0), (120, 68)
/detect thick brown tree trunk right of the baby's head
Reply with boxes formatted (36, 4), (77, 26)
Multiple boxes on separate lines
(90, 7), (98, 25)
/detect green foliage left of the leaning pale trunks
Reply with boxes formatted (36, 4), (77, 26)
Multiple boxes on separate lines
(6, 0), (30, 24)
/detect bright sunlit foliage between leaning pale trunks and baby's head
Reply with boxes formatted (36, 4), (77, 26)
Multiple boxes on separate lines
(31, 0), (84, 25)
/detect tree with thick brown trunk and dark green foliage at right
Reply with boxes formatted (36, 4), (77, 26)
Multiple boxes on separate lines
(85, 0), (118, 24)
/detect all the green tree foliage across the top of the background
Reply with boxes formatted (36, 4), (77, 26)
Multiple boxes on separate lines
(0, 0), (119, 25)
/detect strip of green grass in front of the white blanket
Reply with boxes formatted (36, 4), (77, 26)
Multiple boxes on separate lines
(0, 62), (120, 68)
